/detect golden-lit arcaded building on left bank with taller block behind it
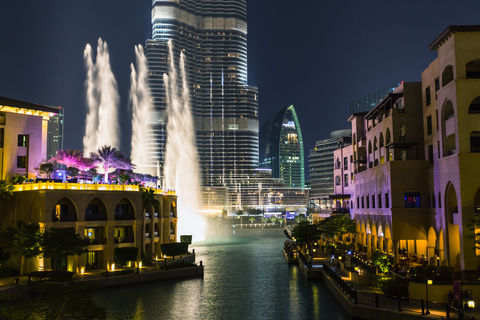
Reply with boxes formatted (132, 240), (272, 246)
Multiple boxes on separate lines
(0, 97), (177, 273)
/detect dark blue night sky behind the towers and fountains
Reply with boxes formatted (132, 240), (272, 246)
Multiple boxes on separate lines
(0, 0), (480, 178)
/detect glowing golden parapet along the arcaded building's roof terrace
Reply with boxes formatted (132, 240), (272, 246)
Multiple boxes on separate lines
(14, 182), (175, 195)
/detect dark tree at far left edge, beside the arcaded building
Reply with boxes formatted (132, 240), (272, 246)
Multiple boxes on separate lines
(2, 220), (41, 276)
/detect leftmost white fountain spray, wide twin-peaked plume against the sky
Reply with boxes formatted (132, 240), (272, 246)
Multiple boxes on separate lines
(83, 38), (120, 154)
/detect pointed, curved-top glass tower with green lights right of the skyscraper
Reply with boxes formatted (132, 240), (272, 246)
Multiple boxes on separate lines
(259, 105), (305, 189)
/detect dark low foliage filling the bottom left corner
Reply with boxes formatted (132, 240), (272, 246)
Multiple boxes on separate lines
(0, 281), (106, 320)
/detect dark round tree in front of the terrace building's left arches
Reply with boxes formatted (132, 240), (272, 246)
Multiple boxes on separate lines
(41, 228), (89, 270)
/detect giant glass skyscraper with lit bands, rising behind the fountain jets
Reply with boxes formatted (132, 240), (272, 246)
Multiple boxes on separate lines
(146, 0), (259, 186)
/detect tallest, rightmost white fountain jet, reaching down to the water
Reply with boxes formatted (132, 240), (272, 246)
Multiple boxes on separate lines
(163, 41), (205, 242)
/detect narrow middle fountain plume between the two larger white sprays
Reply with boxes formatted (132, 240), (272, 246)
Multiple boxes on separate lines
(130, 45), (153, 173)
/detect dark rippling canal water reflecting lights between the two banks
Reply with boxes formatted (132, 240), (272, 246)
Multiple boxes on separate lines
(97, 230), (351, 320)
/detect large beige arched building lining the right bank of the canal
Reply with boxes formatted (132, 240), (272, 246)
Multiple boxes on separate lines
(335, 26), (480, 271)
